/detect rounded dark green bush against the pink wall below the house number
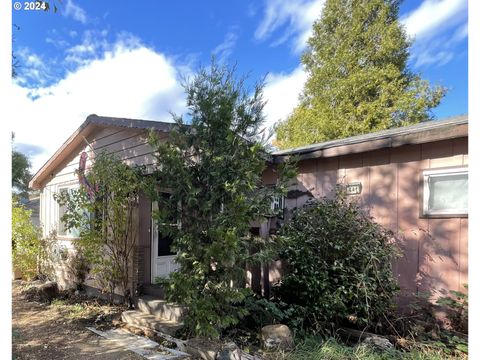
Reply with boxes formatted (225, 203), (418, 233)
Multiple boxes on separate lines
(275, 193), (399, 333)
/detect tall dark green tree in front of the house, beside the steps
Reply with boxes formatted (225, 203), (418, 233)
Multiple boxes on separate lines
(150, 62), (292, 338)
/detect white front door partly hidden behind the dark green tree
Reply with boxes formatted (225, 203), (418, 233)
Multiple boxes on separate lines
(151, 202), (178, 284)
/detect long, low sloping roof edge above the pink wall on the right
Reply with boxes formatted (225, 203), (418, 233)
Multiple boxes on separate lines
(272, 115), (468, 163)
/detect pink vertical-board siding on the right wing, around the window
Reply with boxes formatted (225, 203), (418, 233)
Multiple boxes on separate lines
(270, 132), (468, 303)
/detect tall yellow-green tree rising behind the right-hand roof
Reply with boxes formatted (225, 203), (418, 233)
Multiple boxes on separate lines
(277, 0), (445, 148)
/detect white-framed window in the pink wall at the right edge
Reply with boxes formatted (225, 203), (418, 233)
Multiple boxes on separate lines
(423, 168), (468, 215)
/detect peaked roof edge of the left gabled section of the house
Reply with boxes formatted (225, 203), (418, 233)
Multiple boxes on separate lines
(28, 114), (175, 189)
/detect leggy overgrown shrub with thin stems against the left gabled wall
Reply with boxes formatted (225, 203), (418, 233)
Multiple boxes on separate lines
(54, 151), (144, 303)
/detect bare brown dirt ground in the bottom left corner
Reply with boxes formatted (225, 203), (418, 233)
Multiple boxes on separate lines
(12, 283), (143, 360)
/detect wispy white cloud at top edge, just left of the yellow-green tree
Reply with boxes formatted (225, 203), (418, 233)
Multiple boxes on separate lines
(255, 0), (325, 53)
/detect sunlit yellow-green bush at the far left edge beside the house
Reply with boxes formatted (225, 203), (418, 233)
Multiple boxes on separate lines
(12, 199), (42, 279)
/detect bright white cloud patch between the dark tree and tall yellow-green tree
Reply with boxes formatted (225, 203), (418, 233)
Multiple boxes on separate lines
(264, 66), (307, 128)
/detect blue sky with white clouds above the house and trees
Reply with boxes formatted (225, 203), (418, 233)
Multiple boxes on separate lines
(12, 0), (468, 170)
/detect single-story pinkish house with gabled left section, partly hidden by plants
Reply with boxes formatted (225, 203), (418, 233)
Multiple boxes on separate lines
(30, 115), (468, 304)
